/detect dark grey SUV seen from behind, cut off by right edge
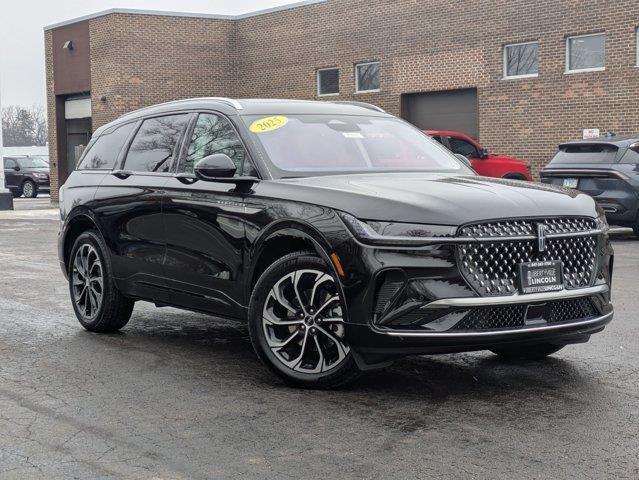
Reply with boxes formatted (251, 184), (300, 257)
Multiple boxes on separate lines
(541, 135), (639, 236)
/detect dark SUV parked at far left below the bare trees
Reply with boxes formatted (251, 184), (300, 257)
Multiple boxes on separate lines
(4, 156), (50, 198)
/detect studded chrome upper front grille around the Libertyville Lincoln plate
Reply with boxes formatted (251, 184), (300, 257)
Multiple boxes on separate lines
(457, 218), (597, 296)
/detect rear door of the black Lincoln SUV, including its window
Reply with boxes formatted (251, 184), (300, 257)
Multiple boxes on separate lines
(94, 113), (192, 303)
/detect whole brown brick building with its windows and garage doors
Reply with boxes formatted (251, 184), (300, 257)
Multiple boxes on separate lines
(45, 0), (639, 201)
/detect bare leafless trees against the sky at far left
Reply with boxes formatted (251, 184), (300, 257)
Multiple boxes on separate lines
(2, 105), (48, 147)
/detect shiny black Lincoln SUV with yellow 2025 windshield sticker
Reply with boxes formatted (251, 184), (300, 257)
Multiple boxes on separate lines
(59, 99), (613, 388)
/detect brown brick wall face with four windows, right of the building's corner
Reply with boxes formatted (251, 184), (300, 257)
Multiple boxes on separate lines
(237, 0), (639, 173)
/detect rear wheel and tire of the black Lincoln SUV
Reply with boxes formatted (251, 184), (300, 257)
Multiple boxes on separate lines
(68, 230), (135, 333)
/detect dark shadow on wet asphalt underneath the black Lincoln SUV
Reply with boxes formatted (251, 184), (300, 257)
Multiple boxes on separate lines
(78, 307), (596, 412)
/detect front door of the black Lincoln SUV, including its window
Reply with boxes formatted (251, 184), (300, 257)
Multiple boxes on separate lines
(163, 112), (257, 317)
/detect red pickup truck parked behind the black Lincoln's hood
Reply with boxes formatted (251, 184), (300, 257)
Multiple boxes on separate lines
(426, 130), (532, 181)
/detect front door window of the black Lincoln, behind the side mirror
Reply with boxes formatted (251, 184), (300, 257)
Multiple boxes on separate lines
(179, 113), (255, 176)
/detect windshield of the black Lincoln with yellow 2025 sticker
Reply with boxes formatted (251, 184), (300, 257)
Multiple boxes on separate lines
(243, 115), (472, 177)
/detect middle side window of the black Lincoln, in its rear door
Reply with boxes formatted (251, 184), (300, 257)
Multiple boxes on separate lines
(124, 114), (189, 172)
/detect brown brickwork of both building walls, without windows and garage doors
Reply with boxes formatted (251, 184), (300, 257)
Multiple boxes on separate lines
(47, 0), (639, 202)
